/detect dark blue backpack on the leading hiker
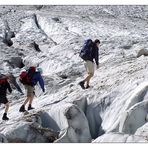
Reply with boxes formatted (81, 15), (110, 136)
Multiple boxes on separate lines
(79, 39), (93, 61)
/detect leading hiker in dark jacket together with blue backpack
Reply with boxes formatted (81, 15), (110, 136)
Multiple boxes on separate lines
(79, 39), (100, 89)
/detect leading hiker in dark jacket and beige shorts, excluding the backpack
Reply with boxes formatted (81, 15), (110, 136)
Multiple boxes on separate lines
(79, 39), (100, 89)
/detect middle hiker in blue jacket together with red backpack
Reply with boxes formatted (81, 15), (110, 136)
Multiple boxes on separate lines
(19, 67), (45, 112)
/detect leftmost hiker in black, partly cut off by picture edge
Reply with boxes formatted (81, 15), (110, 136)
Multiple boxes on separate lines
(0, 74), (12, 120)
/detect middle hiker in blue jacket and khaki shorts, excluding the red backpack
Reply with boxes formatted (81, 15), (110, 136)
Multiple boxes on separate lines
(19, 68), (45, 112)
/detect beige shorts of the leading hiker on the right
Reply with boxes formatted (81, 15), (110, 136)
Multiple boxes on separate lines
(84, 61), (95, 75)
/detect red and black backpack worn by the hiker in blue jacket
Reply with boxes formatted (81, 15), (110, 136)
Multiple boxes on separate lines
(19, 67), (36, 86)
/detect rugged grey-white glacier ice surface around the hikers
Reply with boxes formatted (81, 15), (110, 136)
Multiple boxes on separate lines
(0, 6), (148, 143)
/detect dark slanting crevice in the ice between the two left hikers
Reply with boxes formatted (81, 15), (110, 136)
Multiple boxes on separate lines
(6, 72), (24, 95)
